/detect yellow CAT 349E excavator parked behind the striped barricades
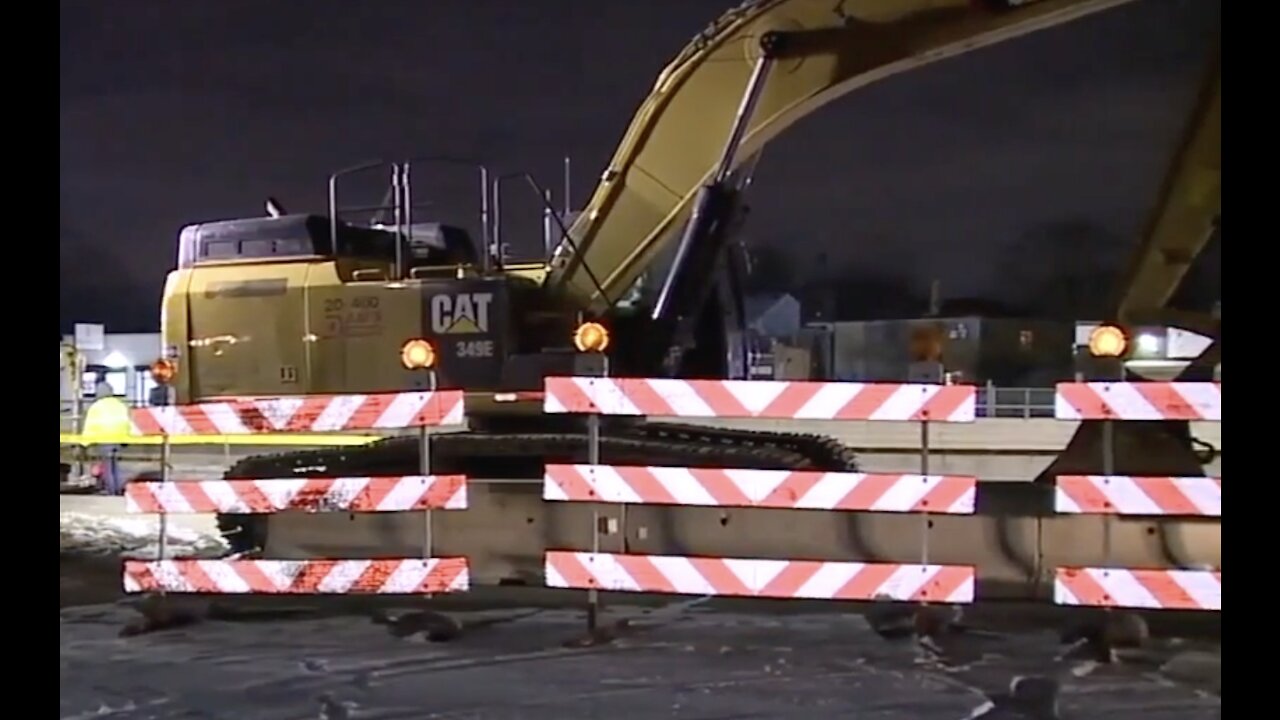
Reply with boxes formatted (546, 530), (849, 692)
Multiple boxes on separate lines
(152, 0), (1220, 577)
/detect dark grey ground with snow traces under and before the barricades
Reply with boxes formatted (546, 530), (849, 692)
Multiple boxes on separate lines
(59, 504), (1221, 720)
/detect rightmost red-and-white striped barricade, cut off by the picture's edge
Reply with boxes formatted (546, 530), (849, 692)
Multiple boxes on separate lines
(1053, 382), (1222, 611)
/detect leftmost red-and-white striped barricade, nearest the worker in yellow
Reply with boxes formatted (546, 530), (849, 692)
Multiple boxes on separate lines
(124, 391), (470, 594)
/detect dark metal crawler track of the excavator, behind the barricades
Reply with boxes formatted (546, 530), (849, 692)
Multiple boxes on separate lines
(218, 423), (858, 555)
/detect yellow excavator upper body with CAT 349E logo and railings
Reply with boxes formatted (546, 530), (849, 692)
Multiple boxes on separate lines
(163, 163), (593, 402)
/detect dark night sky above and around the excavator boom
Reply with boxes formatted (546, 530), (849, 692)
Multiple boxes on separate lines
(59, 0), (1220, 331)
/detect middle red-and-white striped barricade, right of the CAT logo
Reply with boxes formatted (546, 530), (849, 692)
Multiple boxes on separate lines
(543, 377), (977, 619)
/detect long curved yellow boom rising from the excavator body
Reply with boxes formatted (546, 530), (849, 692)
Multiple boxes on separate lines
(548, 0), (1133, 311)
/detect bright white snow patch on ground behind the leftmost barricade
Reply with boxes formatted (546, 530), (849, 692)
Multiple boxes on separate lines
(58, 512), (228, 559)
